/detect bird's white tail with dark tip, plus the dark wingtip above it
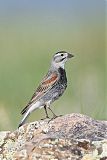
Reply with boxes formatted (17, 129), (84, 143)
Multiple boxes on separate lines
(18, 101), (40, 128)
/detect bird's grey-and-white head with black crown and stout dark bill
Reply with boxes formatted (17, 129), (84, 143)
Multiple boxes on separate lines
(51, 51), (74, 68)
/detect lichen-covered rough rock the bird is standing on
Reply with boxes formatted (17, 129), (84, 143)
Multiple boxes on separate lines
(0, 114), (107, 160)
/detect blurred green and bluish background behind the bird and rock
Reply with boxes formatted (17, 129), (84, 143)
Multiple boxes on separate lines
(0, 0), (107, 130)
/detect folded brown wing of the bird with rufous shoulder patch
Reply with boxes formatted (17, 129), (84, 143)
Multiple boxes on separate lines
(21, 72), (59, 114)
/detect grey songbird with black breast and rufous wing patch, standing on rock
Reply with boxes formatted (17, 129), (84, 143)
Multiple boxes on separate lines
(19, 51), (73, 127)
